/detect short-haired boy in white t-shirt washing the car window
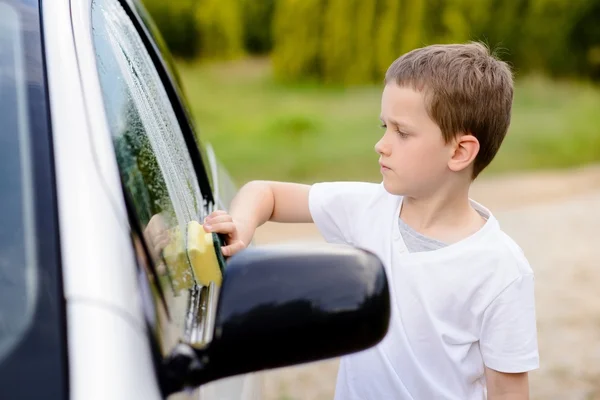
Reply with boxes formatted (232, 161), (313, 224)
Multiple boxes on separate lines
(205, 43), (539, 400)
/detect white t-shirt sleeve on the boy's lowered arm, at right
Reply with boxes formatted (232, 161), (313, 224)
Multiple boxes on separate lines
(479, 274), (539, 373)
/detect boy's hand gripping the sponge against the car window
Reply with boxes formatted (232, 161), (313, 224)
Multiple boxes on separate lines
(203, 210), (255, 257)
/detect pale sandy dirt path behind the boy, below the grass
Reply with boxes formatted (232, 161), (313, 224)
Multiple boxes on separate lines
(256, 166), (600, 400)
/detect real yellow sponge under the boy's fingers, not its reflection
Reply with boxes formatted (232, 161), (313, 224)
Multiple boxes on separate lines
(187, 221), (223, 286)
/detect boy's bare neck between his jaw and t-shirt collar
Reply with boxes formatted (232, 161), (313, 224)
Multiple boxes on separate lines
(400, 180), (485, 244)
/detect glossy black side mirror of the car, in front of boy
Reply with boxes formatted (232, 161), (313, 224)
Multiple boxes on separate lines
(164, 245), (390, 393)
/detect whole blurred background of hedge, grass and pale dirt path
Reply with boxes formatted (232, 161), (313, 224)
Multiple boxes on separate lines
(143, 0), (600, 400)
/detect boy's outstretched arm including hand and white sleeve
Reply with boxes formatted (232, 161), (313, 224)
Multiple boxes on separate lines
(209, 181), (372, 256)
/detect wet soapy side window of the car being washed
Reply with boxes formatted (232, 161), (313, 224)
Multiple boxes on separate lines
(92, 0), (220, 350)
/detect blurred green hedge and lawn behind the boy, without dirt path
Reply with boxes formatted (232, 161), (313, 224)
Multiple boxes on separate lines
(144, 0), (600, 181)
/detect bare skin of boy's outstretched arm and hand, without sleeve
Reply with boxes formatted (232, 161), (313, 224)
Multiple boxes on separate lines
(204, 181), (312, 256)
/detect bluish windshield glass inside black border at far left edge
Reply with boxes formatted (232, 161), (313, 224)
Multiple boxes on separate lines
(0, 2), (38, 361)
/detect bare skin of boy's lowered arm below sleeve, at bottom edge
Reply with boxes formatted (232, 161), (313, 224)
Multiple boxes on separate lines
(485, 367), (529, 400)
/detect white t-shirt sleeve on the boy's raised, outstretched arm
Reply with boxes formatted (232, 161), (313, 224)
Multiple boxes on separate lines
(308, 182), (377, 245)
